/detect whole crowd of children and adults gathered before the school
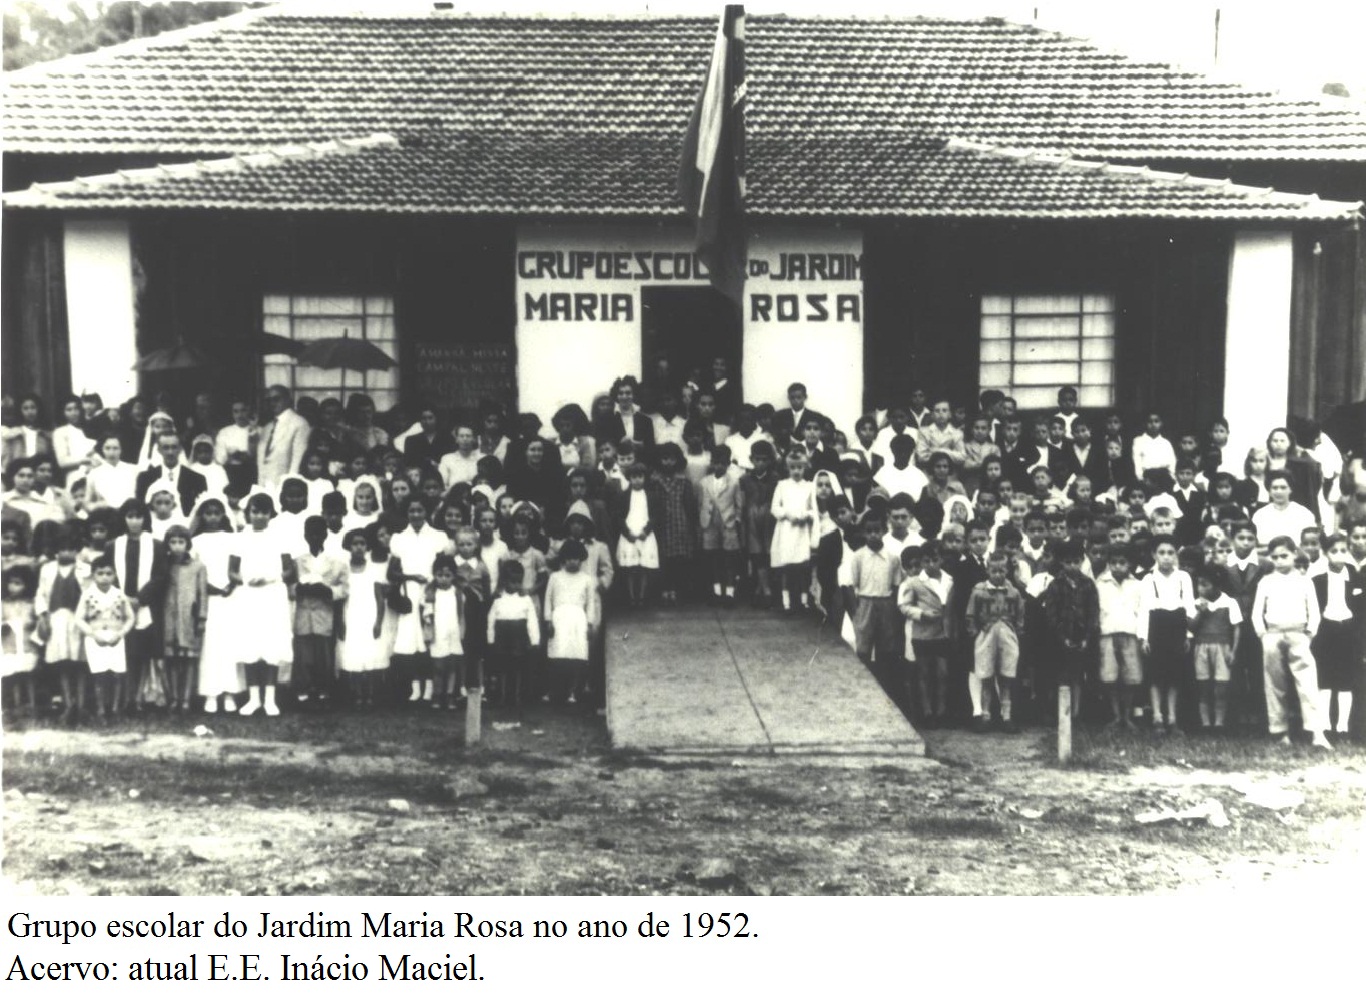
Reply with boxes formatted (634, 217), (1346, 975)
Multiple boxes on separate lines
(0, 374), (1366, 746)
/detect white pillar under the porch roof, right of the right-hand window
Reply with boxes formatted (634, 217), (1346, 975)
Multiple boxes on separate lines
(1224, 231), (1295, 464)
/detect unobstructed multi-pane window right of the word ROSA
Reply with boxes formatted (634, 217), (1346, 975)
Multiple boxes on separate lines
(979, 295), (1115, 410)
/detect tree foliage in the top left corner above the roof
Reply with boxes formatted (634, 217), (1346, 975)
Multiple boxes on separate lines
(4, 0), (262, 70)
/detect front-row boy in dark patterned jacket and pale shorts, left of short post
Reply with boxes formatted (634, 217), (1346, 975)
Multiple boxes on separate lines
(966, 552), (1025, 732)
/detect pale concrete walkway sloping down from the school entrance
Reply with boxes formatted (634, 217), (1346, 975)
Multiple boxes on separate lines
(607, 607), (925, 758)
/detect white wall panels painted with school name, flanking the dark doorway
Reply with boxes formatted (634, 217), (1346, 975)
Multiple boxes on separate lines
(516, 225), (863, 430)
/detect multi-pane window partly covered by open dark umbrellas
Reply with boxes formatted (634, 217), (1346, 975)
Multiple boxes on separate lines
(262, 295), (399, 413)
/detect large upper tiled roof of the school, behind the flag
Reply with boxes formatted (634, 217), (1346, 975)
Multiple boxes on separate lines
(4, 8), (1366, 163)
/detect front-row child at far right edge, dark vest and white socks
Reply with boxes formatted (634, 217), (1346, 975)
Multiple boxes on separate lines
(1311, 534), (1366, 736)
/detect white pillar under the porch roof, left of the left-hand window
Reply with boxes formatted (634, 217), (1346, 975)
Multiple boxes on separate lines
(63, 219), (138, 406)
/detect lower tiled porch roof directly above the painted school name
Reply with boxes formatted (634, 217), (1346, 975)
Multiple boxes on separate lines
(5, 131), (1361, 221)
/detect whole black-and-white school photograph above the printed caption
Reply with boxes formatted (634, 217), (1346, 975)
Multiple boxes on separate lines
(0, 0), (1366, 907)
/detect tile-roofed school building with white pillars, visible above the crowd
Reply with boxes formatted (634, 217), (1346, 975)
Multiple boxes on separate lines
(3, 8), (1366, 456)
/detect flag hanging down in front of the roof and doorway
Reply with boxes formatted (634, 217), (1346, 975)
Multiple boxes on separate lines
(679, 4), (746, 302)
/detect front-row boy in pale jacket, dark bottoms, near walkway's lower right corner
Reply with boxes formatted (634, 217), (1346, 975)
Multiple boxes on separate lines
(896, 540), (953, 727)
